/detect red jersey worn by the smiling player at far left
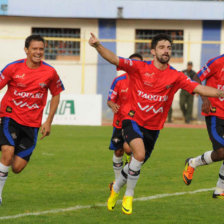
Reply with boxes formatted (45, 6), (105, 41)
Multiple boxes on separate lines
(0, 59), (64, 127)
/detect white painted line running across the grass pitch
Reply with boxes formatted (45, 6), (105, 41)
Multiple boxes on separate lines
(0, 188), (215, 220)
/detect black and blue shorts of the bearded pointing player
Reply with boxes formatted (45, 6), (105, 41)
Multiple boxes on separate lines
(122, 120), (160, 162)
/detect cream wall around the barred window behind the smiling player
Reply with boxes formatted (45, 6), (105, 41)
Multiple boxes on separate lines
(0, 17), (98, 94)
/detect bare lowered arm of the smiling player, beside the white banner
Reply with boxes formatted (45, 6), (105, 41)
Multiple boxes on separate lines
(40, 94), (60, 139)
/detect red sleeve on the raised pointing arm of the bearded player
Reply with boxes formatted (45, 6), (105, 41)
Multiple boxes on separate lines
(117, 57), (142, 76)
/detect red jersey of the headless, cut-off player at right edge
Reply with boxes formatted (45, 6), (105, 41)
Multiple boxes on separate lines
(197, 54), (224, 119)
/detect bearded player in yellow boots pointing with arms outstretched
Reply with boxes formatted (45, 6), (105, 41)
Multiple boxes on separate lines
(89, 33), (224, 214)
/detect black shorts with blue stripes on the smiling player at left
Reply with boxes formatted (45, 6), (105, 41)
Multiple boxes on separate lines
(0, 117), (39, 161)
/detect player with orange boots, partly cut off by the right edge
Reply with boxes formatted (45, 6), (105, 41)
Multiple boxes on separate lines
(183, 55), (224, 199)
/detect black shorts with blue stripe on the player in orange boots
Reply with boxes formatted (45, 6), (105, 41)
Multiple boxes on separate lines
(205, 116), (224, 150)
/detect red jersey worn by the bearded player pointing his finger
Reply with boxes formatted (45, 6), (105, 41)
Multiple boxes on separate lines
(118, 58), (198, 130)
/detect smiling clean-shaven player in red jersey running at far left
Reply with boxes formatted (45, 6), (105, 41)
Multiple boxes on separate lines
(0, 35), (64, 204)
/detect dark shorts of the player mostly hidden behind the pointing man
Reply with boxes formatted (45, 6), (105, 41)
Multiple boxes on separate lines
(109, 127), (124, 150)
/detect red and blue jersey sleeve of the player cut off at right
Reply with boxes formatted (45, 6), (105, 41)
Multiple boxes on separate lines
(197, 58), (216, 81)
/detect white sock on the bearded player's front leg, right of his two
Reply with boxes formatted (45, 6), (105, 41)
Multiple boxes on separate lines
(125, 157), (143, 196)
